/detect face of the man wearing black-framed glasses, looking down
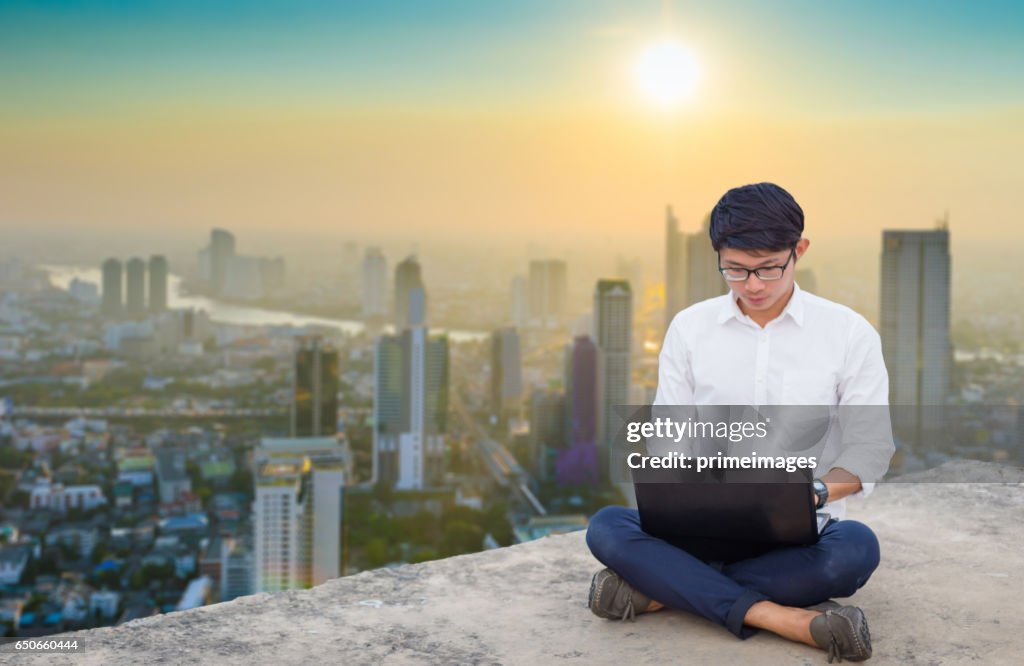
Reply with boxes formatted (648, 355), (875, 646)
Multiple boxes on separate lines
(719, 239), (809, 315)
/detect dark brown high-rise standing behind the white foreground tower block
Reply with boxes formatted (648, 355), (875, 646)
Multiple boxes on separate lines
(291, 336), (338, 438)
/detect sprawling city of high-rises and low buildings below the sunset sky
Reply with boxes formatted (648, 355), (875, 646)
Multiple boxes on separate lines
(0, 207), (1024, 636)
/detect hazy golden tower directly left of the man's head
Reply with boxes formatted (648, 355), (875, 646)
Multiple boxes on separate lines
(665, 206), (728, 327)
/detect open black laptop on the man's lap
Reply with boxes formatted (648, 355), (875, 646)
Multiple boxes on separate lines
(633, 469), (828, 564)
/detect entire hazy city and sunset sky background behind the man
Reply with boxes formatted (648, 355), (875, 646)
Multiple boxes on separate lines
(0, 0), (1024, 637)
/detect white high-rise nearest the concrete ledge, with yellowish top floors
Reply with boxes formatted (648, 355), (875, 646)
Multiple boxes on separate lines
(253, 438), (348, 592)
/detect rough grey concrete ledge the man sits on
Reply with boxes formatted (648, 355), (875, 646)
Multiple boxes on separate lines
(0, 463), (1024, 666)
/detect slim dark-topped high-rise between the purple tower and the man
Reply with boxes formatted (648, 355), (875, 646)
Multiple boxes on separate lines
(594, 280), (633, 478)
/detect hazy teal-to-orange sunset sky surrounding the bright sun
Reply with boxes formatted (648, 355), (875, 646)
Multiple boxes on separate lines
(0, 0), (1024, 252)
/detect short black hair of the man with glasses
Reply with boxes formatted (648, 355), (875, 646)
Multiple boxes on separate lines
(709, 182), (804, 252)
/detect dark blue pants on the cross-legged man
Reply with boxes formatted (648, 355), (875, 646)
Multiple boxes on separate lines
(587, 506), (879, 638)
